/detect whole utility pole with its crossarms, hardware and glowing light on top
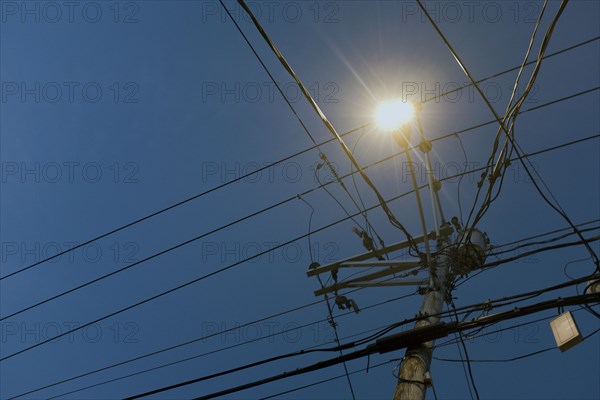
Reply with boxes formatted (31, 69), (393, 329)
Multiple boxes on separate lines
(307, 101), (489, 400)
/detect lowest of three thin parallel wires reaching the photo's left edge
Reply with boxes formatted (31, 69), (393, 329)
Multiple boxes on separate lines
(0, 130), (600, 362)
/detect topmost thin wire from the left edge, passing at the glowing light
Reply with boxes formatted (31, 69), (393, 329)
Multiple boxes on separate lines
(0, 36), (600, 281)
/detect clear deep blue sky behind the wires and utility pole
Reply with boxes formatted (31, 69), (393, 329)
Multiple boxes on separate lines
(0, 0), (600, 399)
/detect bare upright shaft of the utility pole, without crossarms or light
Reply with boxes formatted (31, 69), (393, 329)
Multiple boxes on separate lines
(394, 230), (450, 400)
